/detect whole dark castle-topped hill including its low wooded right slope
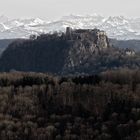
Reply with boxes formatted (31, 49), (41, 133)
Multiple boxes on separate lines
(0, 27), (140, 74)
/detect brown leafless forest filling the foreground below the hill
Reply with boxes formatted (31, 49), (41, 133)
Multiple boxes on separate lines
(0, 69), (140, 140)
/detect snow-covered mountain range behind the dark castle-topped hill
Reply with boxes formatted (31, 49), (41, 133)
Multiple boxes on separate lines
(0, 14), (140, 40)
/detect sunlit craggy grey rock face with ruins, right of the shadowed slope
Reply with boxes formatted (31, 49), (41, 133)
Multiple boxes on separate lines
(64, 27), (110, 69)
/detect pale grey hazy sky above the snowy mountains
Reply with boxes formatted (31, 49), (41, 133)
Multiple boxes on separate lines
(0, 0), (140, 20)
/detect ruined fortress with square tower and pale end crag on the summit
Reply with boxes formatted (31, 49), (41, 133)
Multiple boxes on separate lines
(66, 27), (109, 49)
